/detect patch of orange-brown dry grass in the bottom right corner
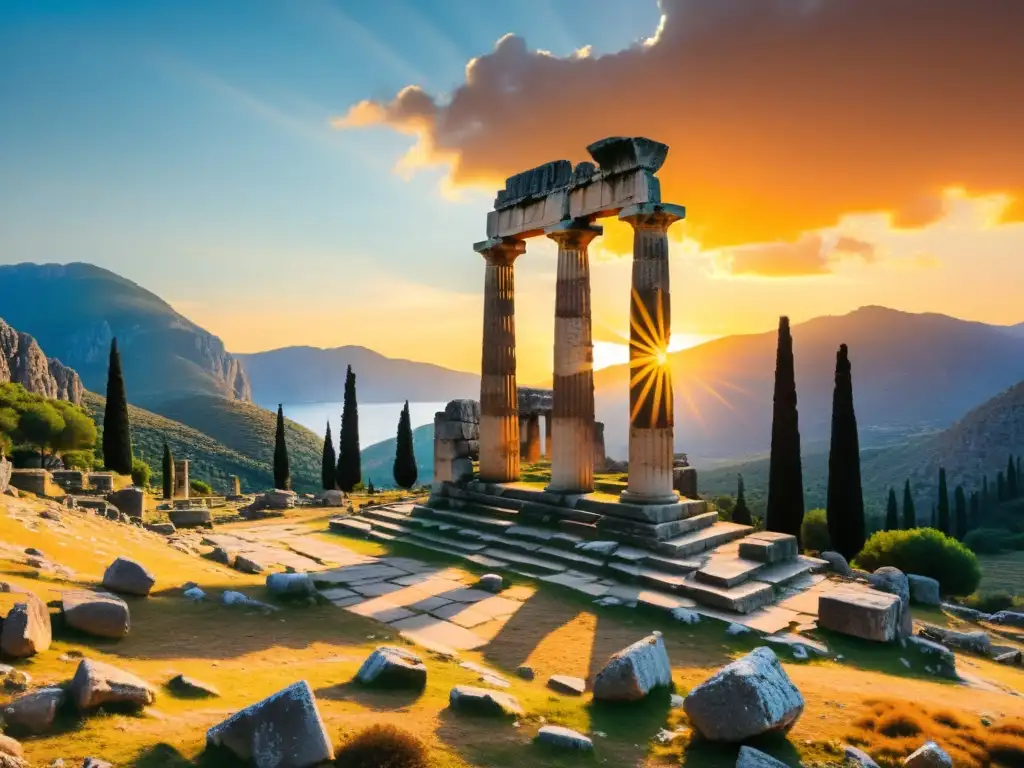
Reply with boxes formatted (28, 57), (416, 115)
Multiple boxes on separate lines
(847, 699), (1024, 768)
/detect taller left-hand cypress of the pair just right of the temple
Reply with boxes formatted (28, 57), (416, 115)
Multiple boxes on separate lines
(765, 317), (804, 542)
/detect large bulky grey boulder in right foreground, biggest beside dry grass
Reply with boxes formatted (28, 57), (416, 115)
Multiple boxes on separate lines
(683, 646), (804, 741)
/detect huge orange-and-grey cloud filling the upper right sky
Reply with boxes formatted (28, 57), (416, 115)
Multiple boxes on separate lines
(335, 0), (1024, 252)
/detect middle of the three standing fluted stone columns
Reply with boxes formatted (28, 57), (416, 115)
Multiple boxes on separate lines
(545, 221), (602, 494)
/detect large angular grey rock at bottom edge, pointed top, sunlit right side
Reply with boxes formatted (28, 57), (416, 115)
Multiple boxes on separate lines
(206, 680), (334, 768)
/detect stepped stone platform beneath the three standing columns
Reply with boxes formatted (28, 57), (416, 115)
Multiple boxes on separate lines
(330, 480), (827, 618)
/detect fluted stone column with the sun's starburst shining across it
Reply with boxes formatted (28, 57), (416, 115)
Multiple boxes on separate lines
(618, 203), (686, 504)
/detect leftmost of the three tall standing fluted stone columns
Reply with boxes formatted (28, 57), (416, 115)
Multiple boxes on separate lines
(473, 238), (526, 482)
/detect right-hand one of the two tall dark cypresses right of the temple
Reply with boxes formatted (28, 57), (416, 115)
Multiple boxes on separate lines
(825, 344), (864, 560)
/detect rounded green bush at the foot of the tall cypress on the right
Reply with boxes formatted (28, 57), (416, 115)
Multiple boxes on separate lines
(856, 528), (981, 595)
